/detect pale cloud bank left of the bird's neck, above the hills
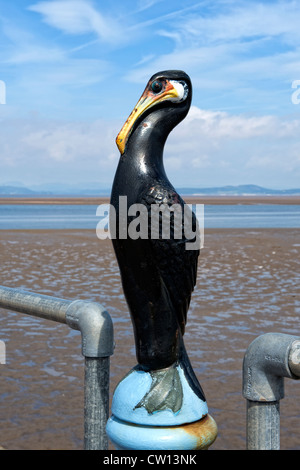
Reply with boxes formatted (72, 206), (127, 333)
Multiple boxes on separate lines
(0, 116), (121, 186)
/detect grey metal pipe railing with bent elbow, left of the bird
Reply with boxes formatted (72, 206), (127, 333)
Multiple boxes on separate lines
(0, 286), (114, 450)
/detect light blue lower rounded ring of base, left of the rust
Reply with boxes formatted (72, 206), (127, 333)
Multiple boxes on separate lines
(106, 416), (198, 450)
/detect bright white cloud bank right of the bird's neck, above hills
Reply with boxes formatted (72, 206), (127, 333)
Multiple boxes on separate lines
(165, 106), (300, 187)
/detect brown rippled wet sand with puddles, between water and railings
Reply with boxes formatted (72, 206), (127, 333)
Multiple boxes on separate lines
(0, 229), (300, 450)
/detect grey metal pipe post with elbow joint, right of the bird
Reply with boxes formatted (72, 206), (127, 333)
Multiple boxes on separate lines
(243, 333), (300, 450)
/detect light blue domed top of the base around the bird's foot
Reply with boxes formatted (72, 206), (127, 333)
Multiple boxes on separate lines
(110, 365), (208, 432)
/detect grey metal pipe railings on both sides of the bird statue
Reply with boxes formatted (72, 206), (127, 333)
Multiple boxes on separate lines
(0, 280), (300, 450)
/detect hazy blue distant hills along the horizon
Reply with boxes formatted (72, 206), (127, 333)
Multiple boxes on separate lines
(0, 183), (300, 197)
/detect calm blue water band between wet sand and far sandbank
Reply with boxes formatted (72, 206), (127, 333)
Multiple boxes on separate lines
(0, 204), (300, 230)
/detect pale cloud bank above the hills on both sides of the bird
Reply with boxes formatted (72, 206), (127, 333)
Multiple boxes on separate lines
(0, 106), (300, 187)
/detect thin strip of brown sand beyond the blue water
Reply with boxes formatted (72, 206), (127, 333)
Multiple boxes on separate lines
(0, 195), (300, 205)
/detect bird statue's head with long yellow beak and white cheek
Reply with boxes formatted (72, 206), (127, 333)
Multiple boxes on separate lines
(116, 70), (192, 154)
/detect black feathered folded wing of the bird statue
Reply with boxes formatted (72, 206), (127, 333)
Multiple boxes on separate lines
(142, 185), (200, 334)
